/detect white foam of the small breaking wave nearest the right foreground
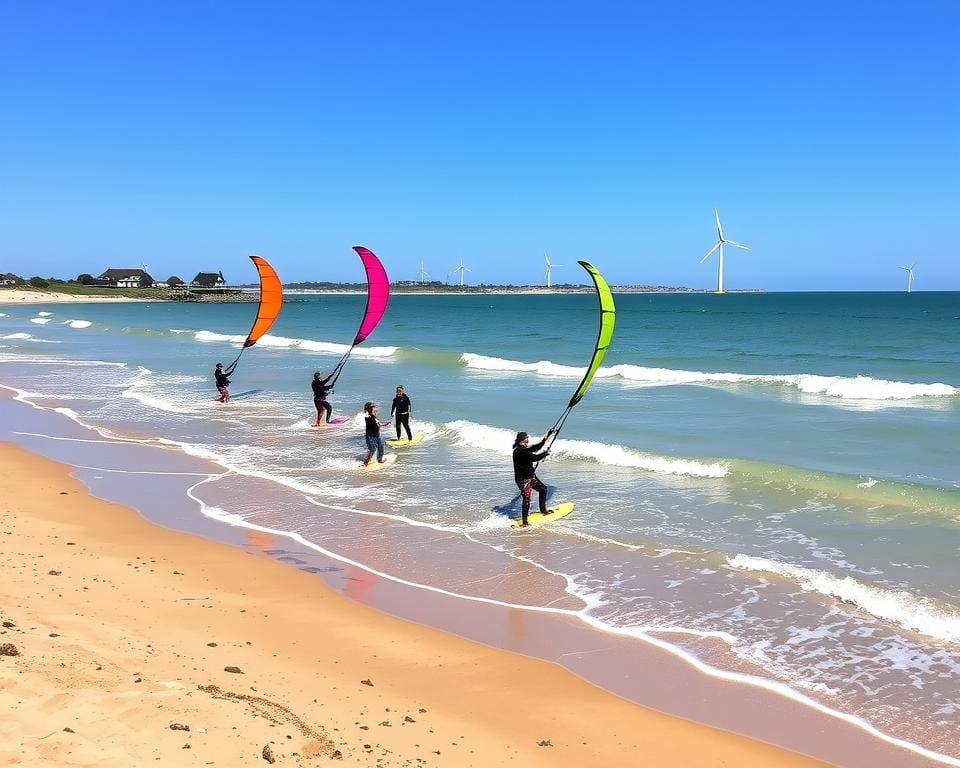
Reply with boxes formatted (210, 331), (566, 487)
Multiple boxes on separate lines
(727, 555), (960, 643)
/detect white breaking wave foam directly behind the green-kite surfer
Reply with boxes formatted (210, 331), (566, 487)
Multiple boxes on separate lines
(444, 421), (730, 477)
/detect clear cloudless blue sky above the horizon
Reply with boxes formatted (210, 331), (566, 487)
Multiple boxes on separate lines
(0, 0), (960, 290)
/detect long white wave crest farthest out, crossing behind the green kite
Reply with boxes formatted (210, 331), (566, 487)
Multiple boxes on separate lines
(460, 352), (960, 400)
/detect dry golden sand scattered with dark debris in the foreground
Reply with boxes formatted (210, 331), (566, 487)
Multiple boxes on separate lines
(0, 444), (824, 768)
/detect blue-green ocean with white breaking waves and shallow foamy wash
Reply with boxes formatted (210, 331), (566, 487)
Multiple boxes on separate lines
(0, 293), (960, 764)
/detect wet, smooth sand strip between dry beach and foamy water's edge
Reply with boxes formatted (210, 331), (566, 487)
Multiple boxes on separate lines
(0, 390), (950, 767)
